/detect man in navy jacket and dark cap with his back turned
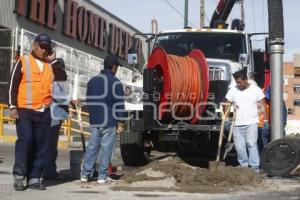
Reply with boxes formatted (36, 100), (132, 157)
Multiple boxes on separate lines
(81, 55), (124, 184)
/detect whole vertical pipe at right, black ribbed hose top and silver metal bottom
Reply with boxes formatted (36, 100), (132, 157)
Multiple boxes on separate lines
(268, 0), (284, 141)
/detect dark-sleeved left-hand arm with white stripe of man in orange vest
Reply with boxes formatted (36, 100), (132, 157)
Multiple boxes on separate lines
(8, 59), (22, 119)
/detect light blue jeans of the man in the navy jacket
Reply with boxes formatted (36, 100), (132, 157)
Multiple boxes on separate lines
(81, 127), (116, 180)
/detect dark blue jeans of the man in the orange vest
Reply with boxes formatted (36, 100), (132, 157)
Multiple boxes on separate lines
(13, 109), (51, 179)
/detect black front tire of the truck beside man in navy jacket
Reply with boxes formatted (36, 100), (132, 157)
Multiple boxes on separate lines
(120, 132), (150, 166)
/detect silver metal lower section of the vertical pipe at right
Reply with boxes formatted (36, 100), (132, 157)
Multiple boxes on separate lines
(270, 41), (284, 141)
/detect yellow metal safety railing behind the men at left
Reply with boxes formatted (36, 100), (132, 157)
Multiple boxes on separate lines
(0, 104), (90, 143)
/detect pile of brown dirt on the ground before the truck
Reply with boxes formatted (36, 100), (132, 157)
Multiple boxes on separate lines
(122, 157), (263, 187)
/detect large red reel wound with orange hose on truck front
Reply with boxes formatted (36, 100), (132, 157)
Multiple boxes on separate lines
(148, 47), (209, 123)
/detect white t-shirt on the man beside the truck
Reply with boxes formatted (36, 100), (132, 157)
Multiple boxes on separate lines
(225, 84), (265, 126)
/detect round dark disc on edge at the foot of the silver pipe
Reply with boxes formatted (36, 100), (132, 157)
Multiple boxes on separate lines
(261, 137), (300, 176)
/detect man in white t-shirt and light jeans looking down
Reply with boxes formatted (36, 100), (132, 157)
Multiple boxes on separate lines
(225, 70), (265, 172)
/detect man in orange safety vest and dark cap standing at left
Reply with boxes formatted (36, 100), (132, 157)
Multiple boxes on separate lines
(9, 34), (53, 190)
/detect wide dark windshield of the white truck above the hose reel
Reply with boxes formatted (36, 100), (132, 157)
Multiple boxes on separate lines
(153, 32), (247, 62)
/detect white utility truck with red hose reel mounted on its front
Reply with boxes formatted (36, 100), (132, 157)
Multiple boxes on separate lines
(120, 1), (265, 166)
